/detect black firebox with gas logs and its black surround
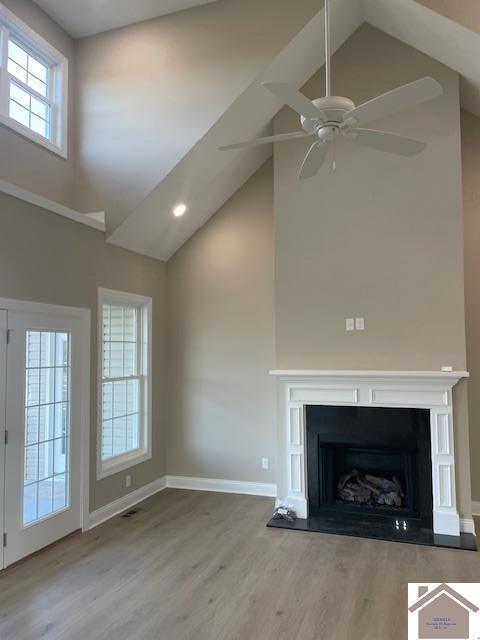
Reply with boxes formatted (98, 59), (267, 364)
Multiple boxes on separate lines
(306, 406), (433, 530)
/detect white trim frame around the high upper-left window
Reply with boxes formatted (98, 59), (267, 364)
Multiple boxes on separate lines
(0, 2), (68, 160)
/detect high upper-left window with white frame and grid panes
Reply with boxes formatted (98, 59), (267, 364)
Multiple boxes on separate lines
(0, 3), (68, 158)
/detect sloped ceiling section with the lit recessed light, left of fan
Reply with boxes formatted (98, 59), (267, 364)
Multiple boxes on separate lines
(109, 0), (363, 260)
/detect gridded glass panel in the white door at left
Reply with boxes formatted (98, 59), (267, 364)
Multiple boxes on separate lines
(23, 330), (71, 526)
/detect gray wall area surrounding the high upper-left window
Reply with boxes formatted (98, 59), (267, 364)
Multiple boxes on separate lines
(0, 0), (75, 207)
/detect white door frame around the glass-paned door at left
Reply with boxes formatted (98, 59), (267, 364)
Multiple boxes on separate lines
(0, 298), (92, 540)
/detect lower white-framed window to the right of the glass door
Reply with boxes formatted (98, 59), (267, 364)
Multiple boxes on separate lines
(99, 289), (151, 476)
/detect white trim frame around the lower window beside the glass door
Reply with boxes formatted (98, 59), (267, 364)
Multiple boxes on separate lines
(97, 287), (152, 480)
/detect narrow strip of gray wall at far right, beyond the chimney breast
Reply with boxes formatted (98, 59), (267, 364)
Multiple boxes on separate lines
(462, 111), (480, 502)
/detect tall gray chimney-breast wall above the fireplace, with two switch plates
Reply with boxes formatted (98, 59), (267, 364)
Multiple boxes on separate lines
(275, 25), (471, 516)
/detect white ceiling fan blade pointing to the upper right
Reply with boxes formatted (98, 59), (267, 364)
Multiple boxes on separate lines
(345, 77), (443, 124)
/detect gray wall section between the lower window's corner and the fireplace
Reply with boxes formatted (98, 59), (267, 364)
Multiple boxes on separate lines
(167, 162), (276, 482)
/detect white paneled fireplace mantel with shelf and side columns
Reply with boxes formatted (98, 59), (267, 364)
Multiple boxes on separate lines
(270, 369), (469, 536)
